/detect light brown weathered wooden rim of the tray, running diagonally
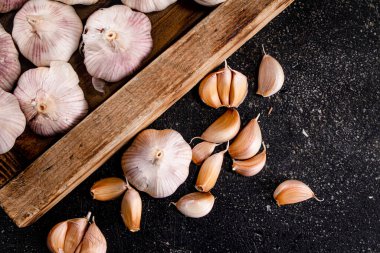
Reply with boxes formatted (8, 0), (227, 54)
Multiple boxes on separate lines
(0, 0), (293, 227)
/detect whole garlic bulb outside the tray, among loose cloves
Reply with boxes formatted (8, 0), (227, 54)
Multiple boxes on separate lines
(121, 129), (192, 198)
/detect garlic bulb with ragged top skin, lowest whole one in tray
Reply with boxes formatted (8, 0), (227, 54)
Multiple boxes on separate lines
(14, 61), (88, 136)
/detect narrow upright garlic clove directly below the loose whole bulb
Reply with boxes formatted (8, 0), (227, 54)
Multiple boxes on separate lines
(121, 186), (142, 232)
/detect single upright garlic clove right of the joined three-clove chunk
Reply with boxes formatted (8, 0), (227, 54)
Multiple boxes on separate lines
(256, 54), (285, 97)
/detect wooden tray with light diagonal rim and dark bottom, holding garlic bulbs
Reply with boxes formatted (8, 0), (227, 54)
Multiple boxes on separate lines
(0, 0), (293, 227)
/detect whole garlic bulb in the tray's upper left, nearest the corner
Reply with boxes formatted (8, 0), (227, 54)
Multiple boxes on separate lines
(12, 0), (83, 67)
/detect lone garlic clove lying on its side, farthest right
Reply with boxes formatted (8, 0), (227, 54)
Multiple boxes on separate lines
(273, 180), (320, 206)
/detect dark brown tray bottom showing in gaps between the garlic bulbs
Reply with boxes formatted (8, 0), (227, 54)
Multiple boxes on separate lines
(0, 0), (210, 188)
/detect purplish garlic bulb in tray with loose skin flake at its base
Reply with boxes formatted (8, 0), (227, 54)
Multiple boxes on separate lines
(83, 5), (153, 92)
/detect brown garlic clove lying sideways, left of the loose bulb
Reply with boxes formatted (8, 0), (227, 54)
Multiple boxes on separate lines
(91, 177), (127, 201)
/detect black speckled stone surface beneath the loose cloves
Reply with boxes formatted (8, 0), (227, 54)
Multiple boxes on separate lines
(0, 0), (380, 252)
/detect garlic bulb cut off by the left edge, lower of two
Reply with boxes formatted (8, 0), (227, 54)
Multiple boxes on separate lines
(0, 89), (26, 154)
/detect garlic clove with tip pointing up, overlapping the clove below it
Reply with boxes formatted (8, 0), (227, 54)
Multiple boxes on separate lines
(228, 115), (262, 160)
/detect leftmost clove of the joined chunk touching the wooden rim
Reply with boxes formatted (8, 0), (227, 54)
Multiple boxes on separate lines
(199, 73), (222, 109)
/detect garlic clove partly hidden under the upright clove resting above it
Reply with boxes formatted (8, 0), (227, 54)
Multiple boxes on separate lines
(232, 143), (267, 177)
